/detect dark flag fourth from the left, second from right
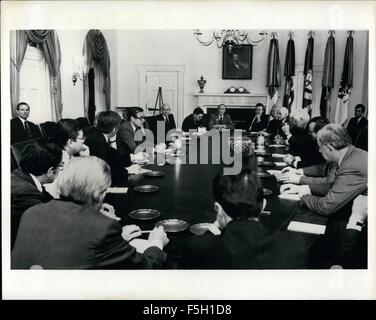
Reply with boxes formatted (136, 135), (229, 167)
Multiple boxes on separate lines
(320, 31), (335, 120)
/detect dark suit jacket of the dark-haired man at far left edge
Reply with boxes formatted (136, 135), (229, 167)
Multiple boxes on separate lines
(11, 169), (52, 248)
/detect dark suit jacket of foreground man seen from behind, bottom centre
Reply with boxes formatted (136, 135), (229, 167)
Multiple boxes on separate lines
(184, 220), (308, 269)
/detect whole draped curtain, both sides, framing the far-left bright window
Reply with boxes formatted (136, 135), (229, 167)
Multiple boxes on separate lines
(10, 30), (63, 120)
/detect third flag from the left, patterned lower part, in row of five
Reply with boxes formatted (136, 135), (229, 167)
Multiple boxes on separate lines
(302, 34), (315, 115)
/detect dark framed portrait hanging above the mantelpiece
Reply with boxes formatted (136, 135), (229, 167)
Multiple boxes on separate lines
(222, 45), (253, 80)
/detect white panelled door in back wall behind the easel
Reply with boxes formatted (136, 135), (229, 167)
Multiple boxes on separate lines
(140, 66), (184, 127)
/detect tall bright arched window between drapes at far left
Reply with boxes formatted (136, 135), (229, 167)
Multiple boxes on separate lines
(19, 46), (56, 123)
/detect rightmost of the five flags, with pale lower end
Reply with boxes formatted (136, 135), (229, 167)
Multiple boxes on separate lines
(334, 31), (353, 125)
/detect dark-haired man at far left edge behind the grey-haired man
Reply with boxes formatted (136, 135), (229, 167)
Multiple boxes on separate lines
(11, 142), (62, 248)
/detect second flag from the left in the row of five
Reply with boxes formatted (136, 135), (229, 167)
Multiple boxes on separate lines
(283, 33), (295, 112)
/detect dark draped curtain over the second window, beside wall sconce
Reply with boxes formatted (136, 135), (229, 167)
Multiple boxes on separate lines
(83, 30), (111, 116)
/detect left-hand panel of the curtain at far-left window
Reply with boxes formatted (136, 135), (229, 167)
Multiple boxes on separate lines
(10, 30), (27, 116)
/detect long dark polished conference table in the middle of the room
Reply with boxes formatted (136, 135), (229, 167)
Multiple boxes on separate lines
(105, 130), (326, 269)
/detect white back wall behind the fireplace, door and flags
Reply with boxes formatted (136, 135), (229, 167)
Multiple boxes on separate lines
(58, 30), (368, 124)
